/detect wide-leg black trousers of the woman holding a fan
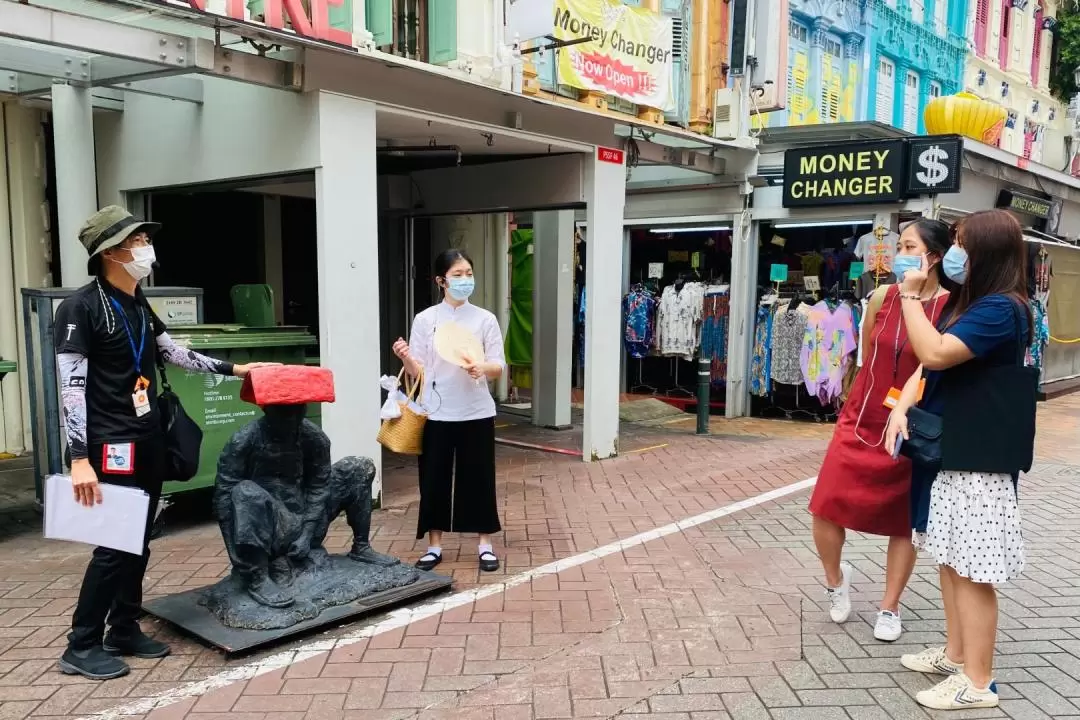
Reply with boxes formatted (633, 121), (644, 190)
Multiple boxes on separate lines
(416, 418), (502, 540)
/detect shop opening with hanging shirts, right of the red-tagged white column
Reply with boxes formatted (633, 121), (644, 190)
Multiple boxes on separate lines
(575, 176), (747, 413)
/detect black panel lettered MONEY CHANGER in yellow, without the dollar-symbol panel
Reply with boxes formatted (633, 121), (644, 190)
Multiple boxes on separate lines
(783, 139), (905, 207)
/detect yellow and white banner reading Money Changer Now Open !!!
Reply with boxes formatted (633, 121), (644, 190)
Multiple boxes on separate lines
(554, 0), (675, 111)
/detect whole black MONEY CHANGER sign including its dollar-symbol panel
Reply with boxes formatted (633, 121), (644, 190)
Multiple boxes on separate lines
(783, 136), (963, 207)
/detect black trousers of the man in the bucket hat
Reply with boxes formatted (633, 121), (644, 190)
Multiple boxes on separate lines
(68, 437), (164, 650)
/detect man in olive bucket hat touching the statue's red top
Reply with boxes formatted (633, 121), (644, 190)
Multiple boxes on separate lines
(54, 205), (274, 680)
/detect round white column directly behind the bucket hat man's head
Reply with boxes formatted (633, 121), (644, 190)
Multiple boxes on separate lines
(52, 83), (97, 287)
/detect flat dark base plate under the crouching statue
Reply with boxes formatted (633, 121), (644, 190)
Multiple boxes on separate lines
(143, 571), (454, 655)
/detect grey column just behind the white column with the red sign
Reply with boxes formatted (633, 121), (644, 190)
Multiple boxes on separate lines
(532, 210), (574, 427)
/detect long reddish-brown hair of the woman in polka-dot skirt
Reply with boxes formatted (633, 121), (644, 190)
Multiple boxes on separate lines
(948, 209), (1032, 342)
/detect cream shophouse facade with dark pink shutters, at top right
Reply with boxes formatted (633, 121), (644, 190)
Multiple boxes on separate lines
(963, 0), (1066, 162)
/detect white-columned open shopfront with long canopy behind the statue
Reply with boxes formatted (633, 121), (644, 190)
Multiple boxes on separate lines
(0, 2), (756, 479)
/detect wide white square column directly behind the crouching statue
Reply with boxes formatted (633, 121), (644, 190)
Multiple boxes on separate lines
(315, 92), (382, 498)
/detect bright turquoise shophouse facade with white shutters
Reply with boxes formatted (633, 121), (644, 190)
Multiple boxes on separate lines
(864, 0), (969, 133)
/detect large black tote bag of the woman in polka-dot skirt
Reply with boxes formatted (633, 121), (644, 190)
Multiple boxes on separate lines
(942, 303), (1039, 473)
